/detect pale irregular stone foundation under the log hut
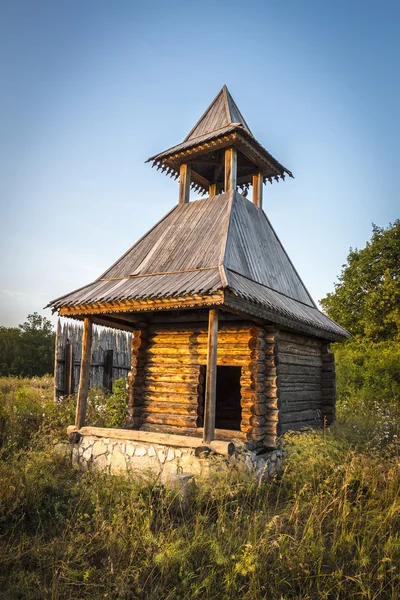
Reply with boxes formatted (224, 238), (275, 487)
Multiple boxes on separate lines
(65, 436), (284, 481)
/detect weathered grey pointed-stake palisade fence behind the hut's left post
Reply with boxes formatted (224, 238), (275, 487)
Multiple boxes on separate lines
(54, 320), (132, 400)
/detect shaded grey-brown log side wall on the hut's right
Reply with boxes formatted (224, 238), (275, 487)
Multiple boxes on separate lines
(278, 331), (324, 435)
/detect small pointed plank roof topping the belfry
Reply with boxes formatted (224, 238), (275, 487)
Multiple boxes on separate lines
(184, 85), (253, 142)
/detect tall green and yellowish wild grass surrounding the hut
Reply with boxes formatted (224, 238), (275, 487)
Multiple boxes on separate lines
(0, 378), (400, 600)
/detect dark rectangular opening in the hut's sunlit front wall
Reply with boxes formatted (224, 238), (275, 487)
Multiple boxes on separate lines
(199, 367), (242, 431)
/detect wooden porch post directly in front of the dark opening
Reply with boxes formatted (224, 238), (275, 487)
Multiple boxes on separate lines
(203, 308), (218, 444)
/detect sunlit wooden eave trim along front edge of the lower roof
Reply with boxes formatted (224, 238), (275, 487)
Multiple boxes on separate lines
(60, 291), (228, 317)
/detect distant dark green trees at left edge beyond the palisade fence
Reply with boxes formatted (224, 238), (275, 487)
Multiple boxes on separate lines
(0, 313), (55, 377)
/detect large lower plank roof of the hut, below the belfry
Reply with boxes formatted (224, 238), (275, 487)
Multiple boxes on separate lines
(49, 191), (348, 340)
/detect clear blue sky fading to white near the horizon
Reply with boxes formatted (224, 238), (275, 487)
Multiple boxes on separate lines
(0, 0), (400, 325)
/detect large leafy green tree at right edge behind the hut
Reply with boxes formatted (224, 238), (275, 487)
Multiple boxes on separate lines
(320, 219), (400, 342)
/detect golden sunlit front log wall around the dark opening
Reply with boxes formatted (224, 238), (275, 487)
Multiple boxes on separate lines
(128, 322), (278, 446)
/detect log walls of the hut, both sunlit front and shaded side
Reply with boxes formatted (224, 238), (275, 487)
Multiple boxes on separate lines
(128, 322), (335, 447)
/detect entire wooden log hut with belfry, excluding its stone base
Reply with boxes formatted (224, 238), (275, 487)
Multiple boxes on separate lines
(50, 86), (349, 460)
